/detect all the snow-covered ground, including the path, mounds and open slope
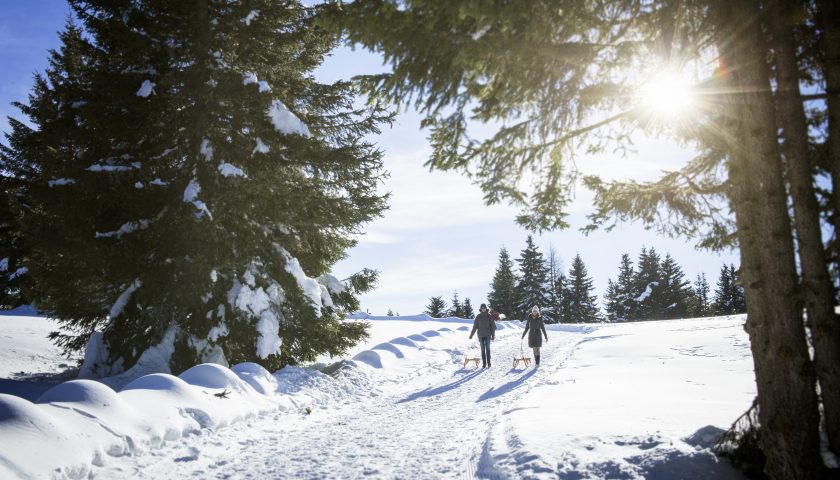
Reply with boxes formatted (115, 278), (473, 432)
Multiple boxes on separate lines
(0, 316), (755, 479)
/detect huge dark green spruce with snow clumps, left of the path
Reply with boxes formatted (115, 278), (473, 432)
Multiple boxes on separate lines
(0, 0), (387, 375)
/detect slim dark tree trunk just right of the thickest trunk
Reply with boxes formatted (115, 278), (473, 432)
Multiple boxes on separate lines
(767, 0), (840, 458)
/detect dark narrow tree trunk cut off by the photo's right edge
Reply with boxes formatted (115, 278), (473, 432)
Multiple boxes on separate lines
(817, 0), (840, 235)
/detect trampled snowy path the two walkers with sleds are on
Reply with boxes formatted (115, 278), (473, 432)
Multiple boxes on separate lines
(98, 327), (584, 479)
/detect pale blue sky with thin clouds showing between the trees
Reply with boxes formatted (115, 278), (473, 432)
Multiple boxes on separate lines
(0, 0), (738, 315)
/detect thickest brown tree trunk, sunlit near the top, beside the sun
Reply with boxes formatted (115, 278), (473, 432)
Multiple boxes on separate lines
(712, 0), (824, 480)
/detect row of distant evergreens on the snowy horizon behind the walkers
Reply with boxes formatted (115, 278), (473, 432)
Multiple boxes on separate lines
(487, 236), (746, 323)
